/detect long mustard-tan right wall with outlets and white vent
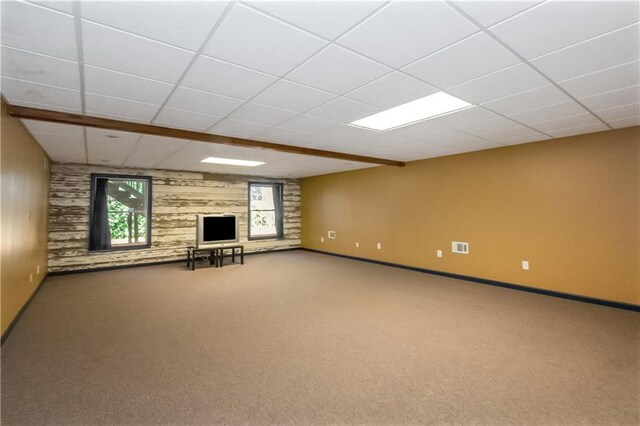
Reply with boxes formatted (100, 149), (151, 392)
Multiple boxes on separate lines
(302, 127), (640, 304)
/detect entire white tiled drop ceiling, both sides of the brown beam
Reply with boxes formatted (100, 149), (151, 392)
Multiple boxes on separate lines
(1, 0), (640, 177)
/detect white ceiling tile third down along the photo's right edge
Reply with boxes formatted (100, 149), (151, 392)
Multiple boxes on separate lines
(558, 61), (640, 98)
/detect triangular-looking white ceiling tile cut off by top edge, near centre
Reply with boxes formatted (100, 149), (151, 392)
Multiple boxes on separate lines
(249, 1), (384, 39)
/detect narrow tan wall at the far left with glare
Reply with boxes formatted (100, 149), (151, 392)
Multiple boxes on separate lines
(0, 102), (49, 334)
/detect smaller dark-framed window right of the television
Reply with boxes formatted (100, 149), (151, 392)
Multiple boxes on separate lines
(249, 182), (283, 240)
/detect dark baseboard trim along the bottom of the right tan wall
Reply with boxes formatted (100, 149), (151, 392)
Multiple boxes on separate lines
(300, 247), (640, 312)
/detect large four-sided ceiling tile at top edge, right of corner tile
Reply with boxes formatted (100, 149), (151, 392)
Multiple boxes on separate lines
(82, 1), (228, 51)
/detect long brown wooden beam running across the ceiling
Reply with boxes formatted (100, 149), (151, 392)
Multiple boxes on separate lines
(7, 104), (404, 167)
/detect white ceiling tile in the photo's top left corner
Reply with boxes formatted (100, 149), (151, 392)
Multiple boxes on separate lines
(0, 1), (78, 61)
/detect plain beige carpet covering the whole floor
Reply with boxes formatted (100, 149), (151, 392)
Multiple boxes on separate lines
(2, 251), (640, 425)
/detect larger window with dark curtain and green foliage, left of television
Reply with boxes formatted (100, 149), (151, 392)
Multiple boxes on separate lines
(89, 173), (151, 251)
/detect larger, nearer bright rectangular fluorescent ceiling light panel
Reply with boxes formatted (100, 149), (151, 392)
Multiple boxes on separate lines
(351, 92), (471, 131)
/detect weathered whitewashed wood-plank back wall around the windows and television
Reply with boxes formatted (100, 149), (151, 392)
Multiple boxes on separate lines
(49, 164), (300, 272)
